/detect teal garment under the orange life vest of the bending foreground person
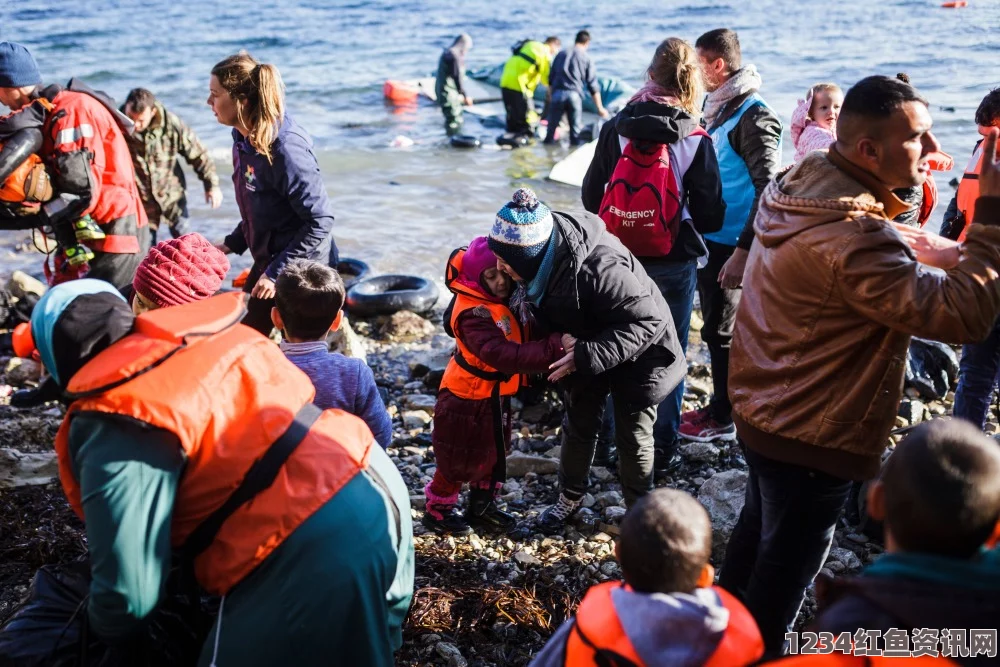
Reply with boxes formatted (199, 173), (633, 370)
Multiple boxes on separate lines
(69, 414), (414, 666)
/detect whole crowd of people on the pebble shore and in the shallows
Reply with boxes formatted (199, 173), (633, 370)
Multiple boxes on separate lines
(0, 18), (1000, 666)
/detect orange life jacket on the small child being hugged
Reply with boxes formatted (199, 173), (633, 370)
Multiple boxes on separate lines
(441, 248), (524, 399)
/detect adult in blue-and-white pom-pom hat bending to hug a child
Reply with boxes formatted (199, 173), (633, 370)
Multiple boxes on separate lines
(489, 189), (686, 532)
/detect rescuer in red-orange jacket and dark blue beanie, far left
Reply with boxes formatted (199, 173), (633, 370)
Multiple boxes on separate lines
(0, 42), (149, 294)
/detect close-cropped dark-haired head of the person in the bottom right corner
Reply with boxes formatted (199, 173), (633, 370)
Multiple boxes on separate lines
(882, 419), (1000, 558)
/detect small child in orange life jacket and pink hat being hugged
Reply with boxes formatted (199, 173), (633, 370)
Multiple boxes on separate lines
(423, 236), (563, 535)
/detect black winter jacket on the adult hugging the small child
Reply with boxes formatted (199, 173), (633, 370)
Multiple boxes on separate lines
(535, 212), (687, 410)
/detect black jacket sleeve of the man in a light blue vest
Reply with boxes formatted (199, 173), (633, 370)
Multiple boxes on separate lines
(708, 93), (781, 250)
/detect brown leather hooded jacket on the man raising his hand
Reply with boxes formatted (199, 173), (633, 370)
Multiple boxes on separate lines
(729, 147), (1000, 479)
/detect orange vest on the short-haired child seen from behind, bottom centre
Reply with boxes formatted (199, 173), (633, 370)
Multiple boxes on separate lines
(564, 581), (764, 667)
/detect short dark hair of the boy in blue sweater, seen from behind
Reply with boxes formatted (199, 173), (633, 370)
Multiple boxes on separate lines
(274, 259), (345, 340)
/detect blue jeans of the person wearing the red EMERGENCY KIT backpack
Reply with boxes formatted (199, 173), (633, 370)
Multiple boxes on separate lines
(645, 259), (698, 458)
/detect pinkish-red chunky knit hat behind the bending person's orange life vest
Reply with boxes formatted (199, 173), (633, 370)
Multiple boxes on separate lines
(132, 233), (229, 308)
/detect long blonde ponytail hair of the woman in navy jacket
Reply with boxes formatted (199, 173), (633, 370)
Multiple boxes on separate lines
(212, 51), (285, 162)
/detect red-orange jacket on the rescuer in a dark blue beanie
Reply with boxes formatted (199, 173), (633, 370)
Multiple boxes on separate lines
(42, 87), (148, 254)
